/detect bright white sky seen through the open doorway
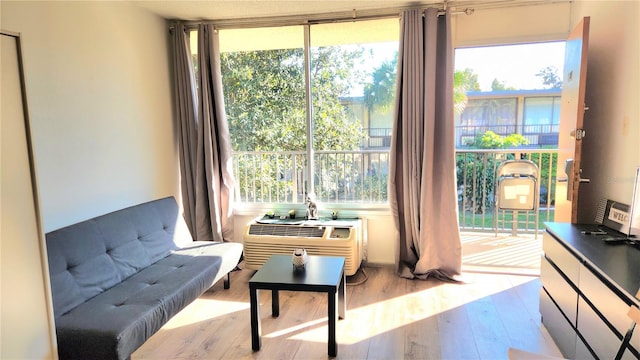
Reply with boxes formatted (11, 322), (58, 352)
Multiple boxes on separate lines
(455, 42), (564, 91)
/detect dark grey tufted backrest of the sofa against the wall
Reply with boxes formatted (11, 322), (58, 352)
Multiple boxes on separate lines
(46, 197), (193, 317)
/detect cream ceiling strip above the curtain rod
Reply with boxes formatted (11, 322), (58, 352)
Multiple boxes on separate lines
(130, 0), (450, 20)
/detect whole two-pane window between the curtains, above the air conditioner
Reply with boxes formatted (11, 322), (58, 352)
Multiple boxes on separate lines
(219, 19), (399, 204)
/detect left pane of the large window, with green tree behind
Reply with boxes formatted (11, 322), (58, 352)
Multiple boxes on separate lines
(220, 26), (307, 202)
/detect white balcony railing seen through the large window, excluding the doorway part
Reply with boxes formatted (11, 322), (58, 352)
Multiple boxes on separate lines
(233, 150), (389, 204)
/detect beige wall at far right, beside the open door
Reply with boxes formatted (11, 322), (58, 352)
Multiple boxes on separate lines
(572, 1), (640, 222)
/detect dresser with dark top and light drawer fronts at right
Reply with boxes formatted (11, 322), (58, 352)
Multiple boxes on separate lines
(540, 223), (640, 359)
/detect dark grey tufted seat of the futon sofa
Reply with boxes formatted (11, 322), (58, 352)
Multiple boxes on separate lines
(56, 250), (225, 359)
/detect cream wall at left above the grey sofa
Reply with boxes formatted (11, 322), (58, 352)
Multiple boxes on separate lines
(0, 1), (178, 232)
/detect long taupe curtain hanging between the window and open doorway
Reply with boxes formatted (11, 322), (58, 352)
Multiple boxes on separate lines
(389, 9), (462, 280)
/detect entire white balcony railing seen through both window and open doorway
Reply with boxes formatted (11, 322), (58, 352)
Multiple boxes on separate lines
(233, 149), (557, 230)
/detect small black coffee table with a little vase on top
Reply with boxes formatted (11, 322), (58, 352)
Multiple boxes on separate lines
(249, 255), (347, 356)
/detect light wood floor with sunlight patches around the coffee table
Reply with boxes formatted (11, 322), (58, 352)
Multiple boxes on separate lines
(132, 267), (559, 360)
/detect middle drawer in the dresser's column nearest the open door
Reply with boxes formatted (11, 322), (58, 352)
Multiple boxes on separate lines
(540, 257), (578, 327)
